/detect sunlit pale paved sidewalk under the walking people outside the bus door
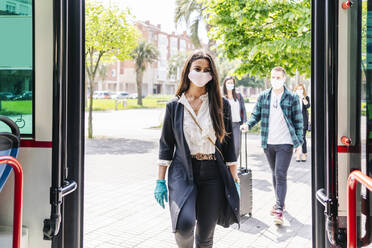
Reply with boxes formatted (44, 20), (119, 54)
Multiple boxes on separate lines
(84, 135), (311, 248)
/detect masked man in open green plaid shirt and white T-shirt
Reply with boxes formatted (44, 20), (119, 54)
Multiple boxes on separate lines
(242, 67), (303, 225)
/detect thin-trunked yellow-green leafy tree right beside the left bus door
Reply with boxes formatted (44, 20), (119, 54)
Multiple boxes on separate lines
(85, 3), (139, 138)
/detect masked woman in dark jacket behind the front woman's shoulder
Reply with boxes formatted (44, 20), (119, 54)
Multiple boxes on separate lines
(223, 77), (247, 158)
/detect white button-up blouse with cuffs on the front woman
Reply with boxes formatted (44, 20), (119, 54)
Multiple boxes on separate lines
(158, 93), (236, 166)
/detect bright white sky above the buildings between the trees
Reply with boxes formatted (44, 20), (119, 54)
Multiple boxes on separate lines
(101, 0), (207, 42)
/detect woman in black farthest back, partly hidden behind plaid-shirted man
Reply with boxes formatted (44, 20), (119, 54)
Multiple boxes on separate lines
(294, 84), (310, 162)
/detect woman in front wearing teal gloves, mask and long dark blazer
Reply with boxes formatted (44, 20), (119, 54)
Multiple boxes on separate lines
(155, 50), (240, 248)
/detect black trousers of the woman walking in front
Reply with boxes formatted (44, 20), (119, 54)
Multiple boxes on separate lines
(175, 159), (225, 248)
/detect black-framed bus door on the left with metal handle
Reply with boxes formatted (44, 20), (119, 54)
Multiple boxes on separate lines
(43, 0), (85, 248)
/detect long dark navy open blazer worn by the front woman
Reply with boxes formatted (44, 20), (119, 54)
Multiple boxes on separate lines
(159, 98), (240, 232)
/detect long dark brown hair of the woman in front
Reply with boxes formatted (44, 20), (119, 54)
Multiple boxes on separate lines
(176, 50), (226, 142)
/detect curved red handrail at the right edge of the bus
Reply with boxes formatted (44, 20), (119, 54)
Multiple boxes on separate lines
(347, 170), (372, 248)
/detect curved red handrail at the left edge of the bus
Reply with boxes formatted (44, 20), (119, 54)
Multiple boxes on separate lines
(0, 156), (23, 248)
